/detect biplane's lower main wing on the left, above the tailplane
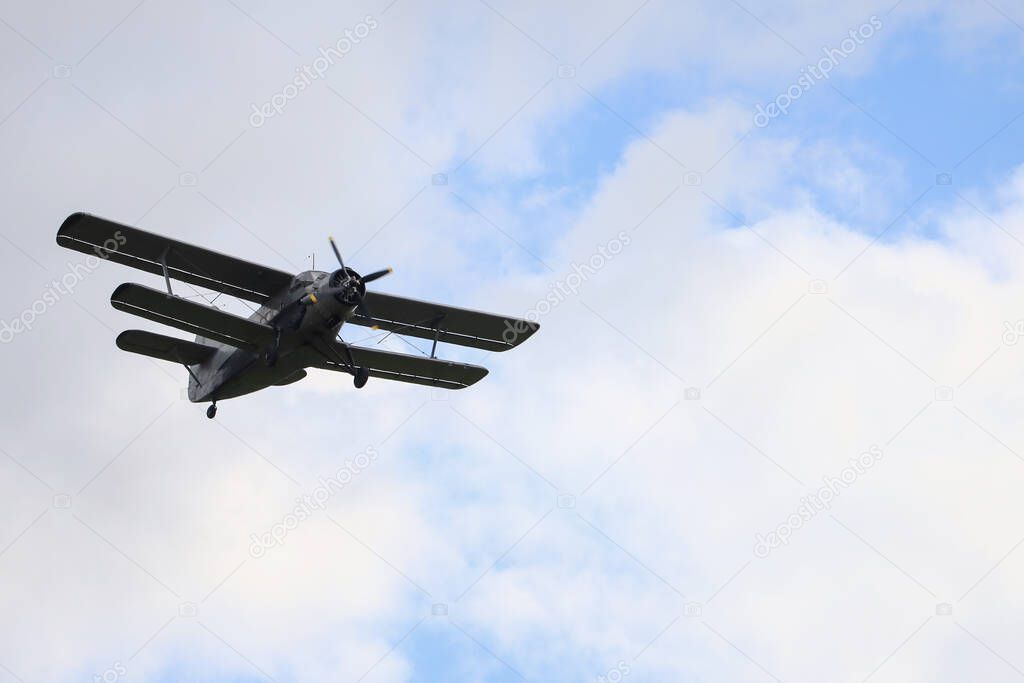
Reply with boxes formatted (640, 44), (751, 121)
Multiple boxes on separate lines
(111, 283), (276, 350)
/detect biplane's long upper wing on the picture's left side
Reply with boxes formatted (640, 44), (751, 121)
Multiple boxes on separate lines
(57, 213), (292, 303)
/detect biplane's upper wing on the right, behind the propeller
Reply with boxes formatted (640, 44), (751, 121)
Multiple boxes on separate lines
(348, 292), (540, 351)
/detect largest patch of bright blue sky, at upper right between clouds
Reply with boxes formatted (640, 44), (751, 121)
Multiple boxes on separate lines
(440, 7), (1024, 290)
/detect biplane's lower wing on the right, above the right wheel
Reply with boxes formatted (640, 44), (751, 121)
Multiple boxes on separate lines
(297, 342), (487, 389)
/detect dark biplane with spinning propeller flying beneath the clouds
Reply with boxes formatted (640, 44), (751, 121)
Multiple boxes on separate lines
(56, 213), (540, 420)
